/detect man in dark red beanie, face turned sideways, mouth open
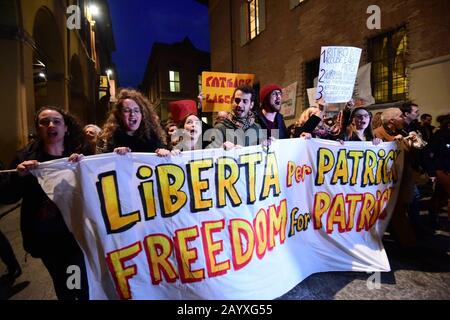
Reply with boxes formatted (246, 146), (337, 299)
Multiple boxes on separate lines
(256, 84), (289, 139)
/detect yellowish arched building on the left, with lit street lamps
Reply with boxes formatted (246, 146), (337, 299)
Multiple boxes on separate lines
(0, 0), (115, 163)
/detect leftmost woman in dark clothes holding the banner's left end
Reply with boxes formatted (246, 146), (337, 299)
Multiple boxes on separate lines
(0, 106), (89, 300)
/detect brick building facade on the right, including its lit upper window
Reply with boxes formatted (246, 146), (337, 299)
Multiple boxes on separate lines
(208, 0), (450, 121)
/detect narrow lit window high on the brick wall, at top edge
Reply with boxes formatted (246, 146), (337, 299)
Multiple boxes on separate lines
(241, 0), (265, 45)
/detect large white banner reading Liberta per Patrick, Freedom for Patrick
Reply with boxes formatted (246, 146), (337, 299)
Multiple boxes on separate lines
(34, 139), (403, 299)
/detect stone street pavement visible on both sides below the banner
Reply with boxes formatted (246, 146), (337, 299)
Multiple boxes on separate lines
(0, 202), (450, 300)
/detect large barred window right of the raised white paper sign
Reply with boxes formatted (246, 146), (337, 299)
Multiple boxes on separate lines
(368, 27), (408, 103)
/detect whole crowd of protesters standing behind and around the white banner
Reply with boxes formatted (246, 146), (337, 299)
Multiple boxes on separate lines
(0, 84), (450, 299)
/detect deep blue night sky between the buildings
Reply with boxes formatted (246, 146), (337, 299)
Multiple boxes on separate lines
(108, 0), (209, 88)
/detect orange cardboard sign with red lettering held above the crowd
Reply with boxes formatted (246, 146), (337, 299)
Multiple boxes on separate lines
(202, 72), (255, 112)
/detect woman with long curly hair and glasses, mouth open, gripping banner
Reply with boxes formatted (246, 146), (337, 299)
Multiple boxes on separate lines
(97, 89), (170, 156)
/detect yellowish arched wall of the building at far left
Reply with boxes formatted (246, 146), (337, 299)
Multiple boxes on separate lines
(0, 0), (114, 163)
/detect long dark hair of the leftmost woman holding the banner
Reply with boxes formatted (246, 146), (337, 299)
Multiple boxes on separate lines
(34, 106), (87, 156)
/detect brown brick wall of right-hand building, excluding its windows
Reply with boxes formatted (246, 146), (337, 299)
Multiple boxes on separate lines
(209, 0), (450, 127)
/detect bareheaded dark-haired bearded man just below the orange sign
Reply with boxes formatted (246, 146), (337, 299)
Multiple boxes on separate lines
(212, 86), (261, 150)
